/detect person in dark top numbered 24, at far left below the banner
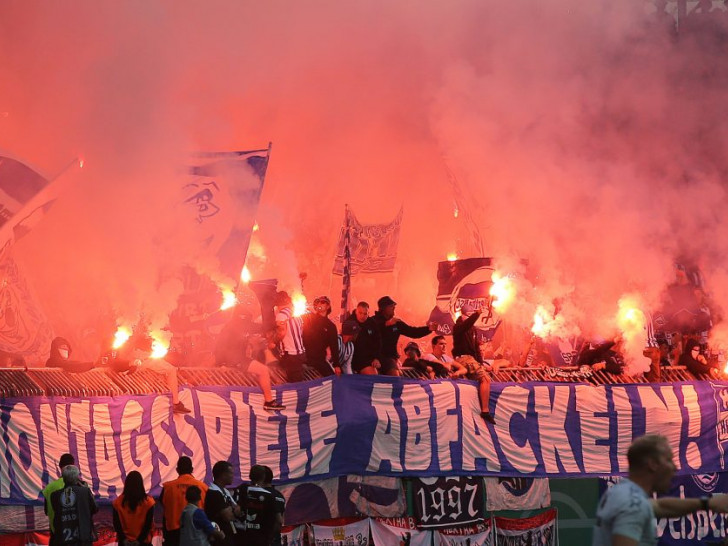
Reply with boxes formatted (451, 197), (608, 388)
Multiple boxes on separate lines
(50, 465), (98, 546)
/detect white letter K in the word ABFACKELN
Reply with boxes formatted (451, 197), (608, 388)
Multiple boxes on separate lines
(533, 385), (579, 472)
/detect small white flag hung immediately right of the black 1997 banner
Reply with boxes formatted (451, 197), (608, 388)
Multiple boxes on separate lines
(485, 478), (551, 512)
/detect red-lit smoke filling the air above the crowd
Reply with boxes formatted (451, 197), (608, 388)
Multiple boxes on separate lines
(0, 0), (728, 364)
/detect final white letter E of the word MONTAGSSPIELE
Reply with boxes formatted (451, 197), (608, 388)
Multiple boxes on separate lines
(306, 381), (339, 474)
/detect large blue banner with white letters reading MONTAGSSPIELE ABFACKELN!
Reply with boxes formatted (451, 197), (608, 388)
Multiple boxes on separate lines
(0, 376), (728, 503)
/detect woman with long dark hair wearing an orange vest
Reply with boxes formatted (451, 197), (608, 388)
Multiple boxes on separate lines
(111, 470), (155, 546)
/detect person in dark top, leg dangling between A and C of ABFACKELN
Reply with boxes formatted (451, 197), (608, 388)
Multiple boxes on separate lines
(452, 303), (495, 424)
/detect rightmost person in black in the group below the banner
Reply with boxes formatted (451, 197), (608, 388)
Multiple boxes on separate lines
(235, 465), (283, 546)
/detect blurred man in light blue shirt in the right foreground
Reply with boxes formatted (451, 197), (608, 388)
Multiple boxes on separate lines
(592, 434), (728, 546)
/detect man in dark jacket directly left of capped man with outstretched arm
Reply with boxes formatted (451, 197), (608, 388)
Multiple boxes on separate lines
(341, 301), (382, 375)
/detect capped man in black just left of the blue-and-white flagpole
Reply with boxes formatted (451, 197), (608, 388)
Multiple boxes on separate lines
(302, 296), (341, 377)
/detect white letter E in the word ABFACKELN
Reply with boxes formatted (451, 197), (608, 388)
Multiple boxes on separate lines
(574, 385), (611, 474)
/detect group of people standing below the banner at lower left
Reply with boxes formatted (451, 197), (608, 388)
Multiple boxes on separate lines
(42, 453), (285, 546)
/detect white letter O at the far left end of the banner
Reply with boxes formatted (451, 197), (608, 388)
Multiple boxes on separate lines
(3, 402), (42, 499)
